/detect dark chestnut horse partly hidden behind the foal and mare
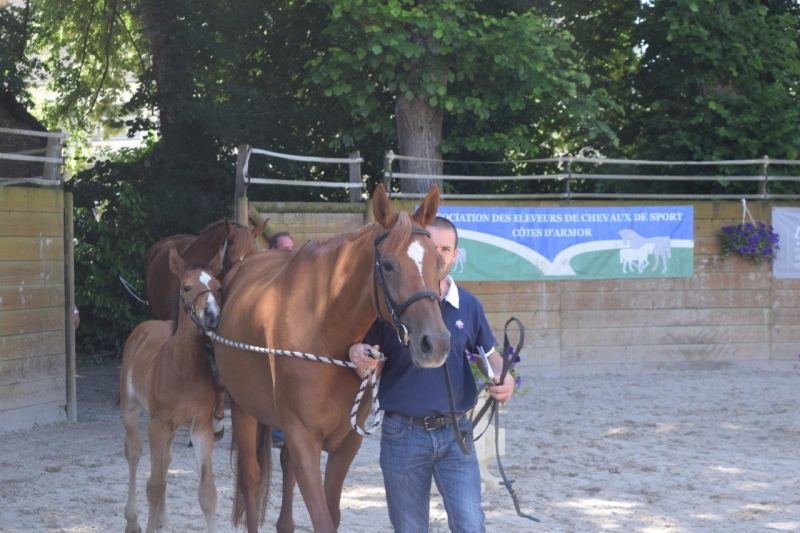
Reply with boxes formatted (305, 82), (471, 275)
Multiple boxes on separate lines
(144, 218), (269, 439)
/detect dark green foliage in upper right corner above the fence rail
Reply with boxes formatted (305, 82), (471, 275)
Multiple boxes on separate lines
(622, 0), (800, 161)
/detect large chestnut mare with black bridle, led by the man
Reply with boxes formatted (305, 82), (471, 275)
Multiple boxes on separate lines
(215, 185), (450, 532)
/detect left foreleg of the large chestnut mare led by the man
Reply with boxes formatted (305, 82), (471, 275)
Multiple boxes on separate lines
(284, 424), (336, 533)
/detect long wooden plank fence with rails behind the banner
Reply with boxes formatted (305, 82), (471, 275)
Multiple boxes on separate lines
(231, 145), (800, 375)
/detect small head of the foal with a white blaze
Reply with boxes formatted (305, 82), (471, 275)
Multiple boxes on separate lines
(169, 247), (222, 331)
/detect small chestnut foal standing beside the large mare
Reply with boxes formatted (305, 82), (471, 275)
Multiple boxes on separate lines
(119, 248), (222, 533)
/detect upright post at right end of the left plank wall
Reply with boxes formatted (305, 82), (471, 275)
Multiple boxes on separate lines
(64, 192), (78, 422)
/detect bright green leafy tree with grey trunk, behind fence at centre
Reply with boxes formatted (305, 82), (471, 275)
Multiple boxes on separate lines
(309, 0), (613, 188)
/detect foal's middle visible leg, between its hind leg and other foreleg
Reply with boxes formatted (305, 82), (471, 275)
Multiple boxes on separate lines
(146, 419), (176, 533)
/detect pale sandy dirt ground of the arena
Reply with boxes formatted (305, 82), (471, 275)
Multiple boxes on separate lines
(0, 362), (800, 533)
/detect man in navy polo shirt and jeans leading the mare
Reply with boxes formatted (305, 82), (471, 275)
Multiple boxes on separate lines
(350, 217), (514, 533)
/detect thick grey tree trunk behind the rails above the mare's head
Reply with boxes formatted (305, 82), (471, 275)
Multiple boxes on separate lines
(395, 96), (444, 194)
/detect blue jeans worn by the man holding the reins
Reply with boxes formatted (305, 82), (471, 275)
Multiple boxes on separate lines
(380, 417), (486, 533)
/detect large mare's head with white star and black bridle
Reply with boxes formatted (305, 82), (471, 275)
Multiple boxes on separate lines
(372, 185), (450, 368)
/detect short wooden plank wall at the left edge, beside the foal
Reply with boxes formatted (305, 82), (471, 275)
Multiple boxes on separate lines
(0, 187), (77, 431)
